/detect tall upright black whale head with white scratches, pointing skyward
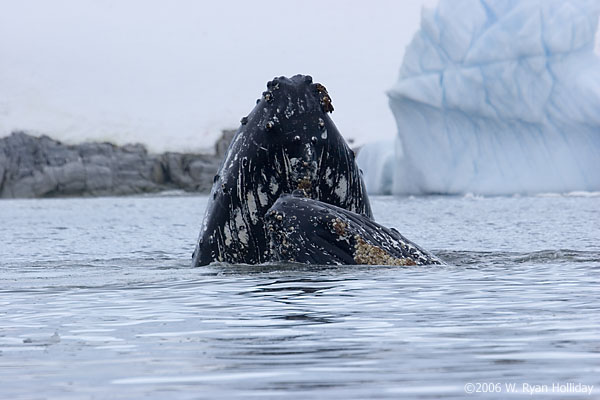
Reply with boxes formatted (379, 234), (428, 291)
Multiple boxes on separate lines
(192, 75), (372, 266)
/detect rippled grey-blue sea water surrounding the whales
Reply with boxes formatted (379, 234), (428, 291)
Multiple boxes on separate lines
(0, 193), (600, 400)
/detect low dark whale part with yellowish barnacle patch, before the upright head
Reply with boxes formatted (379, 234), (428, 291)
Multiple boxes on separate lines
(265, 191), (441, 265)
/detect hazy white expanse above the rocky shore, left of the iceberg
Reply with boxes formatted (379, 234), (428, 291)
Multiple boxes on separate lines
(0, 0), (437, 151)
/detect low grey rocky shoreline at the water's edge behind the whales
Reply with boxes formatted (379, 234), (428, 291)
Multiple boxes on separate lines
(0, 132), (225, 198)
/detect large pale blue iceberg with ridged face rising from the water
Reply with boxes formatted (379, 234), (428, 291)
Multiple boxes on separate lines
(358, 0), (600, 195)
